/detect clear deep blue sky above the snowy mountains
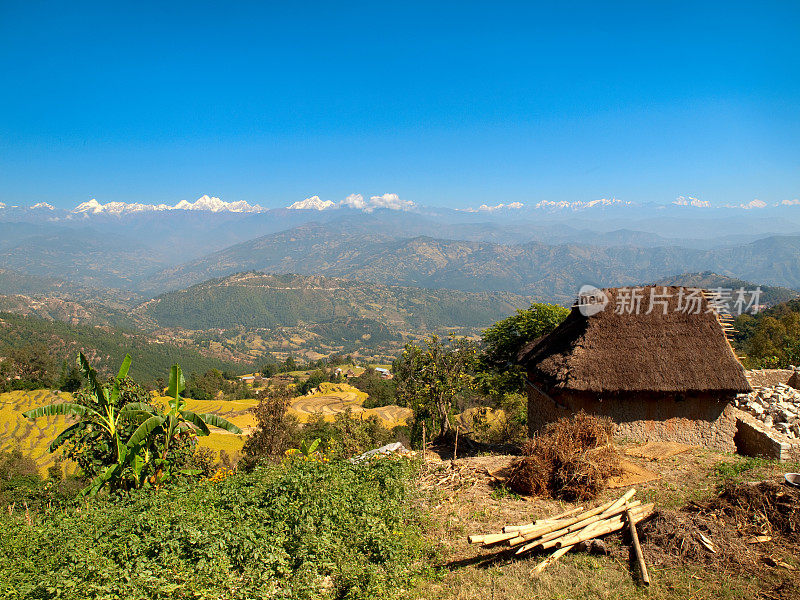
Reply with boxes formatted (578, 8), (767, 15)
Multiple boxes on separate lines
(0, 0), (800, 208)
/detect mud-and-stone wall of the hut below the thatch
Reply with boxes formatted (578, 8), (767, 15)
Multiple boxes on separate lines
(528, 380), (736, 452)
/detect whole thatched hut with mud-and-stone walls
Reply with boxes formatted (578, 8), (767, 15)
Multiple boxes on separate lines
(518, 286), (751, 451)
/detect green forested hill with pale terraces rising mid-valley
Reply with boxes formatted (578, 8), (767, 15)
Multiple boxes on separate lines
(136, 273), (531, 333)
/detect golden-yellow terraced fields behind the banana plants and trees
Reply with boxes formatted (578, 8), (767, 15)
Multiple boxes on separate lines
(0, 383), (413, 474)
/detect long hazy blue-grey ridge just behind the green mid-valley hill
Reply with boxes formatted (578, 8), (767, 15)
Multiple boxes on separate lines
(142, 224), (800, 302)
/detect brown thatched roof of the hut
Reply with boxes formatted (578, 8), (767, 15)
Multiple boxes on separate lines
(518, 286), (750, 393)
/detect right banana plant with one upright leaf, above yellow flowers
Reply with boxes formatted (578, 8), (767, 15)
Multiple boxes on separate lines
(127, 364), (242, 480)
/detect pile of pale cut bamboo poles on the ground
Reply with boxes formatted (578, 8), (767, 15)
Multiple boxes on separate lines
(468, 489), (654, 583)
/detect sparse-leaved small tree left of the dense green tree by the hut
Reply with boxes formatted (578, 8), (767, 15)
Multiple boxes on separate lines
(392, 335), (478, 439)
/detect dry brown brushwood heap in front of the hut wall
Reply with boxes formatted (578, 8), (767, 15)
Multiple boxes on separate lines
(506, 412), (621, 501)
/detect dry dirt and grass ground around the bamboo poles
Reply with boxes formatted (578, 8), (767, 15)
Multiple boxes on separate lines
(411, 443), (800, 600)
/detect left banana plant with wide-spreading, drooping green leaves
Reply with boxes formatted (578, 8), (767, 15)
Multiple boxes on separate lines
(22, 352), (153, 495)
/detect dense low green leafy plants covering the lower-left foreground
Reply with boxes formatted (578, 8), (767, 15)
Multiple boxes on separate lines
(0, 458), (422, 599)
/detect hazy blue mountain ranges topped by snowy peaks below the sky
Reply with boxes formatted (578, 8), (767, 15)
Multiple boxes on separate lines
(0, 194), (800, 302)
